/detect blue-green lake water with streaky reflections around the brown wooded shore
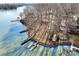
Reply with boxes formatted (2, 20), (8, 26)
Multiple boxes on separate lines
(0, 10), (79, 56)
